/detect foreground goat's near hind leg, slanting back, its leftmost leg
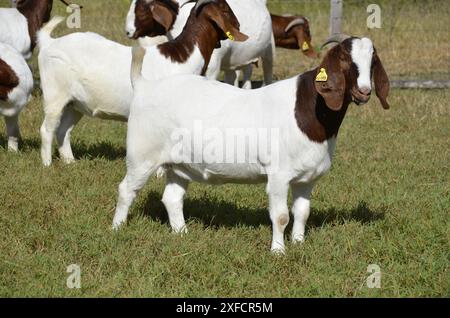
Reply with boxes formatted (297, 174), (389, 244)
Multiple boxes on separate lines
(113, 161), (158, 230)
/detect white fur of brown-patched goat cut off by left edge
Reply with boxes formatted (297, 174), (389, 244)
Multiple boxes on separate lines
(0, 43), (33, 151)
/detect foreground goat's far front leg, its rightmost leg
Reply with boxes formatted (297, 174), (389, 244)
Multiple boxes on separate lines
(291, 184), (314, 243)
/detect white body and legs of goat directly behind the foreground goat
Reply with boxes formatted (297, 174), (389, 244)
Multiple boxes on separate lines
(38, 22), (204, 165)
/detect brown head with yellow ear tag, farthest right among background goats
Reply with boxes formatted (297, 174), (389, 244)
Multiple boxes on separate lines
(284, 16), (319, 58)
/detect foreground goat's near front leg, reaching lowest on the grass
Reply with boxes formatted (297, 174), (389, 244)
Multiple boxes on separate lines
(267, 176), (289, 254)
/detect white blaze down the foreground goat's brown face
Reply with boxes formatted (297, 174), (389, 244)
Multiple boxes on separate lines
(351, 38), (373, 90)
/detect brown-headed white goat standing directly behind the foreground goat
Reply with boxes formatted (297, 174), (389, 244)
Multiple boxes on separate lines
(39, 0), (247, 166)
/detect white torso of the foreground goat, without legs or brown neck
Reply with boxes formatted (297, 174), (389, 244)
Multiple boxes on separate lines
(127, 76), (334, 183)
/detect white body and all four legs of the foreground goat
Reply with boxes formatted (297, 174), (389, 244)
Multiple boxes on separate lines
(113, 75), (335, 252)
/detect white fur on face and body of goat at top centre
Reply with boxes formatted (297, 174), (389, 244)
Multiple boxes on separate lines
(126, 0), (275, 88)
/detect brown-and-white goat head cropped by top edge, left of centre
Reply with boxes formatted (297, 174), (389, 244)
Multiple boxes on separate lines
(125, 0), (179, 39)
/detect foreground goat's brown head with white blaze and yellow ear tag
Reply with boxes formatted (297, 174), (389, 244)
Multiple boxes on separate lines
(315, 37), (390, 111)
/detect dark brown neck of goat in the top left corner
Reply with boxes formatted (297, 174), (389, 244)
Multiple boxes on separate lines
(17, 0), (53, 50)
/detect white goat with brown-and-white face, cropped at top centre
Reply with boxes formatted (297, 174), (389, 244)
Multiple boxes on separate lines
(126, 0), (275, 88)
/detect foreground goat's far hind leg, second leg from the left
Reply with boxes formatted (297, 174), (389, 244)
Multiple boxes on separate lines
(162, 169), (189, 233)
